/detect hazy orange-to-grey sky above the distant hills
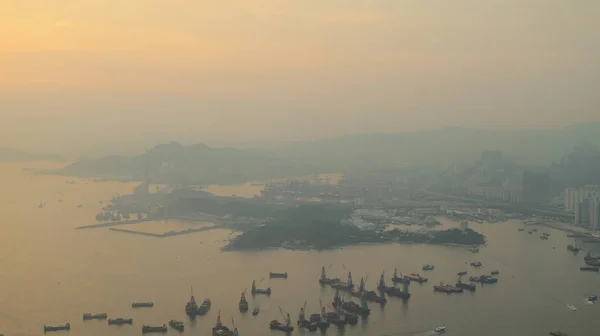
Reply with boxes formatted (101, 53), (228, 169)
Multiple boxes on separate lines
(0, 0), (600, 148)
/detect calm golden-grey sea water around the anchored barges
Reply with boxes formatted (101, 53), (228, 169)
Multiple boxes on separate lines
(0, 164), (600, 336)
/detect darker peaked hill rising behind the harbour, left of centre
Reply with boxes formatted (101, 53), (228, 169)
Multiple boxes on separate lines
(60, 142), (314, 184)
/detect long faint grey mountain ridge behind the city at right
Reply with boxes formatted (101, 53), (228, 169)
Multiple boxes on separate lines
(281, 122), (600, 171)
